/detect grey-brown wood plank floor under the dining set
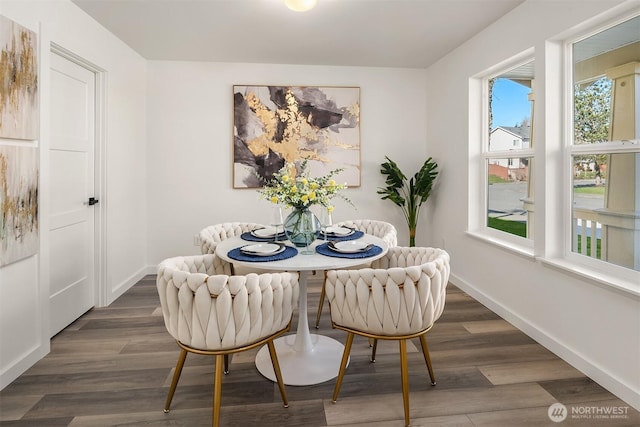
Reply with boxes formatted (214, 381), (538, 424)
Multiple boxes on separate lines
(0, 275), (640, 427)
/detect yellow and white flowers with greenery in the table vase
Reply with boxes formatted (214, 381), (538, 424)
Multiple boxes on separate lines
(258, 160), (351, 211)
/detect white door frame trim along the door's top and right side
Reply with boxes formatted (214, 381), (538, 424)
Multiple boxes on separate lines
(51, 42), (110, 307)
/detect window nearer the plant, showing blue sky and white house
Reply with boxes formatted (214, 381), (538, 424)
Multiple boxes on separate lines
(482, 59), (534, 242)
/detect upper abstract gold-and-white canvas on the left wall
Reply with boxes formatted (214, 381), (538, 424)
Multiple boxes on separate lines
(0, 16), (39, 140)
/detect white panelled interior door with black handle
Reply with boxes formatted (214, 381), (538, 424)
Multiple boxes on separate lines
(49, 52), (96, 336)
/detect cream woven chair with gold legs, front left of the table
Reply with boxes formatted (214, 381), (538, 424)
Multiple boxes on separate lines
(156, 254), (299, 427)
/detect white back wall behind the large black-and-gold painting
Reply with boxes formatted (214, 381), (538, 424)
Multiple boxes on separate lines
(147, 61), (428, 265)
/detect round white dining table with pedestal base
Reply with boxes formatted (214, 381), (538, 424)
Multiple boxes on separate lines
(216, 234), (388, 386)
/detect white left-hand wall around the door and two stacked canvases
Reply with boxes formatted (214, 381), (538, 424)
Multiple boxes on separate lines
(0, 0), (147, 388)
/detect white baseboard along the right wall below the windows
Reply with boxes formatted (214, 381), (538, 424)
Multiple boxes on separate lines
(449, 273), (640, 411)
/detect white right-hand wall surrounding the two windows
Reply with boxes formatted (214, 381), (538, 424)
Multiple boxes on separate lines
(427, 1), (640, 409)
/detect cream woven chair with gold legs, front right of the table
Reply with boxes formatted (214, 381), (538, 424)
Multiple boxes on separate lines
(326, 246), (450, 426)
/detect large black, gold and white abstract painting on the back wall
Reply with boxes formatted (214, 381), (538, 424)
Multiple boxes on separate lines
(233, 86), (360, 188)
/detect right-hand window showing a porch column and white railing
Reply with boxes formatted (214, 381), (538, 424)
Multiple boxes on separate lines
(566, 17), (640, 271)
